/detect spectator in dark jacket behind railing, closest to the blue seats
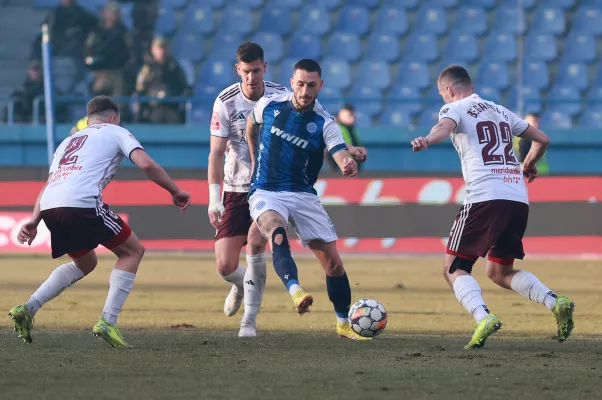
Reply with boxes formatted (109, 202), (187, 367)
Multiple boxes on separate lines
(136, 38), (188, 124)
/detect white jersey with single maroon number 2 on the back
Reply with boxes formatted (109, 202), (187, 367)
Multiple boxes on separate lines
(40, 124), (142, 210)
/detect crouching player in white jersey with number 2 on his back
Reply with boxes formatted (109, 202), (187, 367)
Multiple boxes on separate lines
(9, 96), (190, 347)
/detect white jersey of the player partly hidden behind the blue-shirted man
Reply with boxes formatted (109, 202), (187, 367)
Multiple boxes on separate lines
(211, 81), (288, 193)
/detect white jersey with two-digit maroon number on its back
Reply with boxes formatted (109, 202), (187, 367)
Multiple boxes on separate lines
(439, 94), (529, 204)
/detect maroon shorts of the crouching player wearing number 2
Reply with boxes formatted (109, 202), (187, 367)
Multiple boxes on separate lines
(42, 204), (132, 258)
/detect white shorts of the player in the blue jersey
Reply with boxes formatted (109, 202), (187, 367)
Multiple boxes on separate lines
(249, 189), (338, 247)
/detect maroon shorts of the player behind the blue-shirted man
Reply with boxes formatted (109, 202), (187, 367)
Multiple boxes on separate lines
(215, 192), (253, 241)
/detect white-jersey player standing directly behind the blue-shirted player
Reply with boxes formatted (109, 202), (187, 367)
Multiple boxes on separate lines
(208, 42), (288, 336)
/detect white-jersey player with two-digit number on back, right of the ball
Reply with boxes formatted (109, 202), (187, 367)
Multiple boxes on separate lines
(412, 65), (575, 349)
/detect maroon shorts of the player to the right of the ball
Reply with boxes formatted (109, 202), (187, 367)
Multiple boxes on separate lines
(447, 200), (529, 265)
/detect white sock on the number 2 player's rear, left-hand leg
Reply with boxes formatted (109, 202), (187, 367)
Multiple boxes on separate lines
(25, 262), (84, 317)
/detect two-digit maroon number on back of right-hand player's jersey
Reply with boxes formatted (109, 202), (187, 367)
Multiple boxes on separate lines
(477, 121), (519, 165)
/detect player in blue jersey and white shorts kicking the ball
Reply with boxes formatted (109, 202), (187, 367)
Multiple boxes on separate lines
(247, 59), (367, 340)
